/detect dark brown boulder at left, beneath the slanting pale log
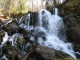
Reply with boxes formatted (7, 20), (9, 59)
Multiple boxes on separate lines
(2, 20), (19, 35)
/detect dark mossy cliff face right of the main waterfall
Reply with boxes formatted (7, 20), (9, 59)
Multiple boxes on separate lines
(58, 0), (80, 52)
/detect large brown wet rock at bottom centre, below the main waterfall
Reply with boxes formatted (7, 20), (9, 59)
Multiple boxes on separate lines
(29, 45), (72, 60)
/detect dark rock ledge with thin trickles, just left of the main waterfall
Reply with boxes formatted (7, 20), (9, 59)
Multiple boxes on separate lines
(19, 12), (38, 26)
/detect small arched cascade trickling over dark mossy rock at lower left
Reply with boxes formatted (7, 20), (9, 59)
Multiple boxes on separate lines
(9, 33), (27, 55)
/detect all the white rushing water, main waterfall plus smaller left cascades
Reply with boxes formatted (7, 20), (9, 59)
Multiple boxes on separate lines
(1, 8), (76, 58)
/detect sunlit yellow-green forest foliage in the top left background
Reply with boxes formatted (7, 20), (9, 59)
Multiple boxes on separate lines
(0, 0), (31, 16)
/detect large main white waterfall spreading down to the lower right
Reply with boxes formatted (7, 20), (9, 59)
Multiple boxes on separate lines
(35, 8), (76, 58)
